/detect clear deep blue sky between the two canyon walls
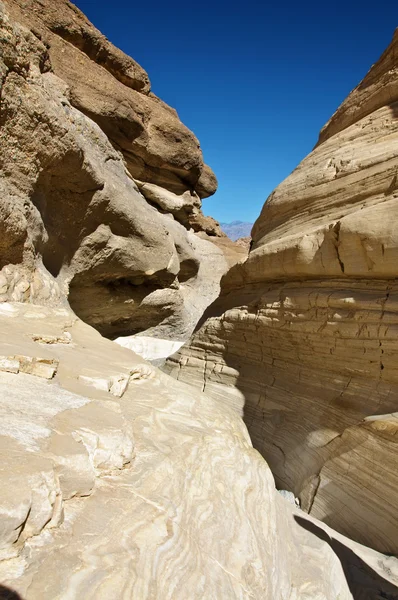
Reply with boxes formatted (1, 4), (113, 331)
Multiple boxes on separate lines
(75, 0), (398, 222)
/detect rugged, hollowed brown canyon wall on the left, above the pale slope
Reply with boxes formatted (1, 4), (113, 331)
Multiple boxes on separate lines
(0, 0), (232, 340)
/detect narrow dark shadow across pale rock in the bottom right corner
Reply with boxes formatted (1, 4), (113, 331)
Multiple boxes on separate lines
(294, 515), (398, 600)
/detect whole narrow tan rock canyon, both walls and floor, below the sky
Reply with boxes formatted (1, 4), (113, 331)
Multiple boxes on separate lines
(0, 0), (398, 600)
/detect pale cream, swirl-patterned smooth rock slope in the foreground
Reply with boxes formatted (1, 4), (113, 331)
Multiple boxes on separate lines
(0, 303), (398, 600)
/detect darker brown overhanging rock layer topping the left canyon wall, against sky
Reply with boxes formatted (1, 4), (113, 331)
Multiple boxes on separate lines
(7, 0), (217, 204)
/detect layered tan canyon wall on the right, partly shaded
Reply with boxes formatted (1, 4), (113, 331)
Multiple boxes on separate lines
(168, 32), (398, 553)
